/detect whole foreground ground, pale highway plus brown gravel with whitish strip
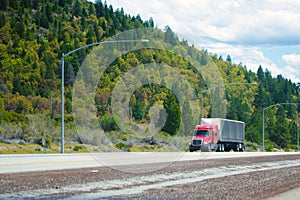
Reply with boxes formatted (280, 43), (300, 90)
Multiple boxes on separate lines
(0, 152), (300, 199)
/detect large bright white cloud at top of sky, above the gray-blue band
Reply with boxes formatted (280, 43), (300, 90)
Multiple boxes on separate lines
(107, 0), (300, 45)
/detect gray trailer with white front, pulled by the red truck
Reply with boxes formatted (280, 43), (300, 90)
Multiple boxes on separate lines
(201, 118), (245, 151)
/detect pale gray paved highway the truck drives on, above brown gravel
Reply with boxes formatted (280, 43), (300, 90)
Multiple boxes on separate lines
(0, 152), (300, 174)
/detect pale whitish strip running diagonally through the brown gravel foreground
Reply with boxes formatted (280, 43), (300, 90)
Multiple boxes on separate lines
(0, 160), (300, 199)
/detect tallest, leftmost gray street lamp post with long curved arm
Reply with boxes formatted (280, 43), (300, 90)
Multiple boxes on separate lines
(61, 39), (149, 153)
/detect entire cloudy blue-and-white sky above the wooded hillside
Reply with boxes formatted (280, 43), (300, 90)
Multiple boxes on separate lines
(106, 0), (300, 83)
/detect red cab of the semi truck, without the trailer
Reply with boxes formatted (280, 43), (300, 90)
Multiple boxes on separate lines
(190, 125), (218, 152)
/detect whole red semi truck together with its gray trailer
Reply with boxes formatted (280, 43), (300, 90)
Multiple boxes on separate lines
(190, 118), (245, 152)
